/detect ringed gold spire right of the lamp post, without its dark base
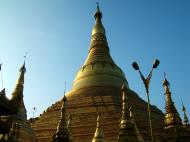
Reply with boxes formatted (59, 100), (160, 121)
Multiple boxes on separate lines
(163, 75), (182, 127)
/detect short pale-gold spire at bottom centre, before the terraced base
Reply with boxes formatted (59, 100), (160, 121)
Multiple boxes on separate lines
(92, 111), (105, 142)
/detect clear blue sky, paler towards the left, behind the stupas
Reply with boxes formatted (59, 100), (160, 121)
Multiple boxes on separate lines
(0, 0), (190, 117)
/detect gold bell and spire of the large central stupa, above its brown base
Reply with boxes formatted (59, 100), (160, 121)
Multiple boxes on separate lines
(73, 5), (128, 89)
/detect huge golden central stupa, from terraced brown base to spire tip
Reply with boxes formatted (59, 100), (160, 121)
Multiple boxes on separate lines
(32, 6), (164, 142)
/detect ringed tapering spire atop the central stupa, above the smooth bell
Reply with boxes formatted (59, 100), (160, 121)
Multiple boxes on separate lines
(84, 5), (112, 67)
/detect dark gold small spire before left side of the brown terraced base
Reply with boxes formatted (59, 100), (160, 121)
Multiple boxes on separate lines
(53, 95), (73, 142)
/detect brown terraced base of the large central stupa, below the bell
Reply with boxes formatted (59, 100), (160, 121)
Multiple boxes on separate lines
(32, 86), (164, 142)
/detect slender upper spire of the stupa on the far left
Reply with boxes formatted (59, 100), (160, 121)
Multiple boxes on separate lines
(10, 62), (27, 120)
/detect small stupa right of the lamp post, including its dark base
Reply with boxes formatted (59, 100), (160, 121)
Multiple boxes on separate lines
(162, 75), (190, 142)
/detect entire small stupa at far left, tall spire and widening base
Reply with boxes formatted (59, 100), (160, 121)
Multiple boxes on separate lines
(3, 63), (36, 142)
